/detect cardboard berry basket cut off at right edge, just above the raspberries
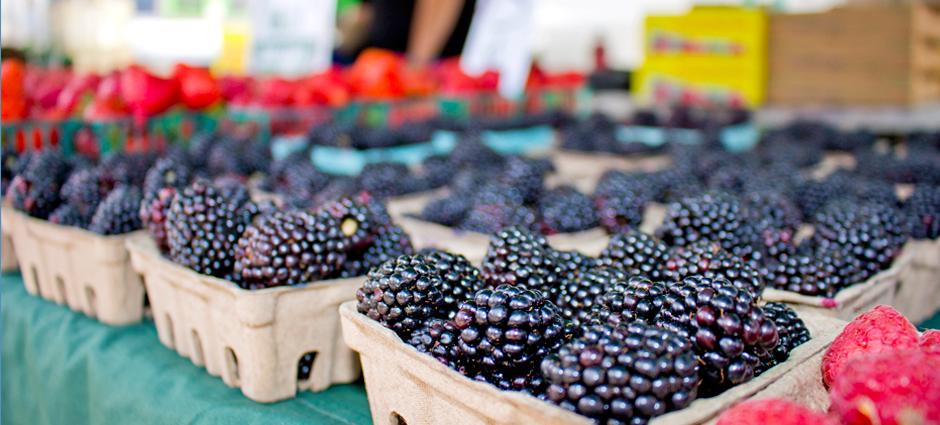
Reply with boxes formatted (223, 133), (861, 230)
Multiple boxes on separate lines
(894, 239), (940, 323)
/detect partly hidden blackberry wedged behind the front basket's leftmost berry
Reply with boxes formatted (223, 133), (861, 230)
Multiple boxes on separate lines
(425, 251), (484, 319)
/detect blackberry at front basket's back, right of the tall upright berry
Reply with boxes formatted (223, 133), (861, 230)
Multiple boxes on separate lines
(598, 230), (669, 280)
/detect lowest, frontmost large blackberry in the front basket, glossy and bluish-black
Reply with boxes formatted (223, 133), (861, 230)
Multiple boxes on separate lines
(541, 322), (700, 424)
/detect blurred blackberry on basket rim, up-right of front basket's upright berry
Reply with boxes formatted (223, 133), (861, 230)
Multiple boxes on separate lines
(539, 186), (598, 234)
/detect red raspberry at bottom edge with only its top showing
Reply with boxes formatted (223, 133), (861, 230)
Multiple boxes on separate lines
(717, 398), (835, 425)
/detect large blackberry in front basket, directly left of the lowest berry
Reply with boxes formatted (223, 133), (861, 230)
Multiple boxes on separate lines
(454, 285), (570, 392)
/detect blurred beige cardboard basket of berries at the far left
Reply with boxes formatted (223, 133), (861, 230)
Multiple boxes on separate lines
(3, 210), (144, 325)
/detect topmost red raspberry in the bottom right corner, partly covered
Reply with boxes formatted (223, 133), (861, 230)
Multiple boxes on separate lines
(822, 305), (918, 388)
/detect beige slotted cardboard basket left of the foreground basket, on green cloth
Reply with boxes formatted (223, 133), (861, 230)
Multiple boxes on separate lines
(127, 235), (364, 403)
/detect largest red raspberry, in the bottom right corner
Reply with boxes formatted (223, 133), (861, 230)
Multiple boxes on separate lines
(829, 348), (940, 425)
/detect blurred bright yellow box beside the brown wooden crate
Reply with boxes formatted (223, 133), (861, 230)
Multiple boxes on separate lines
(632, 6), (767, 106)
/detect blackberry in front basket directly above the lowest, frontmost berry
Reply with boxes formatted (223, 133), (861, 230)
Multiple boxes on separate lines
(589, 276), (668, 325)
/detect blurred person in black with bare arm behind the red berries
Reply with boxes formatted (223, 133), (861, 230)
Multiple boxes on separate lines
(337, 0), (476, 67)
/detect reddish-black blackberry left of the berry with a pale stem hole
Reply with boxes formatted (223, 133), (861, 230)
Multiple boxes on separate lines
(234, 211), (347, 289)
